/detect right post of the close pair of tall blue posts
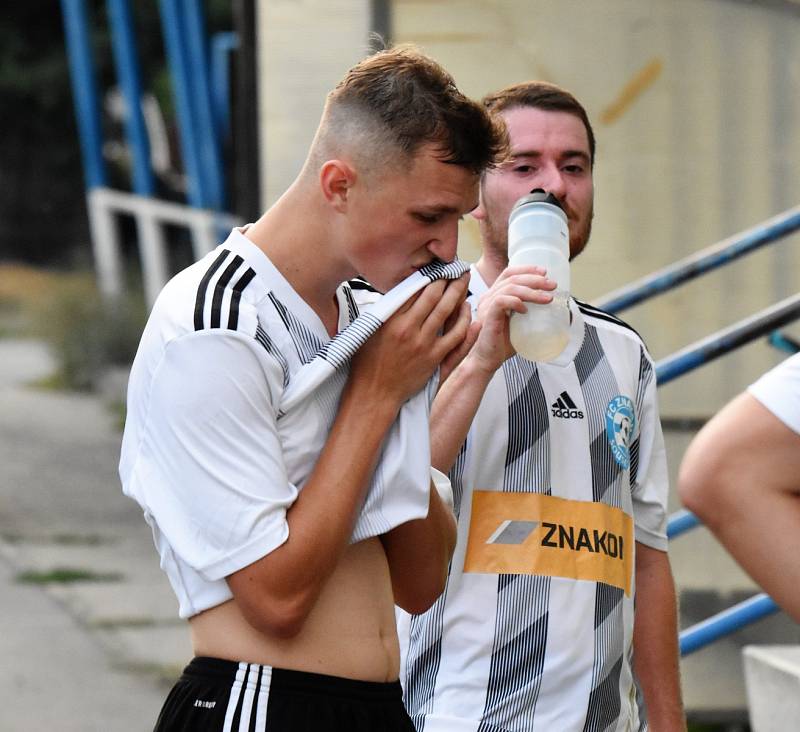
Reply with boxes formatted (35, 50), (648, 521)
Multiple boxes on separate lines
(182, 0), (225, 211)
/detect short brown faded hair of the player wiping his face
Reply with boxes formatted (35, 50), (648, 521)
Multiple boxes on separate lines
(309, 44), (508, 179)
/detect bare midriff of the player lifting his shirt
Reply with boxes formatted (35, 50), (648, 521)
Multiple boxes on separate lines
(189, 538), (400, 681)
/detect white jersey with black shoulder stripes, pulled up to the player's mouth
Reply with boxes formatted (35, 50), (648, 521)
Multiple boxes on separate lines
(120, 230), (430, 617)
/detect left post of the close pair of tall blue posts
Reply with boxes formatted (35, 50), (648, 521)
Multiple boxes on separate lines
(159, 0), (208, 208)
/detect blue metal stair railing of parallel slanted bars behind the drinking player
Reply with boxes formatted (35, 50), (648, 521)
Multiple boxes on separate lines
(597, 206), (800, 656)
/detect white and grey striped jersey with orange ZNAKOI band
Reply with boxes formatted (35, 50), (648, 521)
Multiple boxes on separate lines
(399, 267), (668, 732)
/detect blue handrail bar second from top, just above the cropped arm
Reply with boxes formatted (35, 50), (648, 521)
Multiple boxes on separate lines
(656, 294), (800, 386)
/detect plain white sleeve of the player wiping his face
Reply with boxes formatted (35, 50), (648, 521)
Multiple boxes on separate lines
(128, 330), (297, 581)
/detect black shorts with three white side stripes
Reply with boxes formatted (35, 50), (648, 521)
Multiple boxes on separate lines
(154, 658), (414, 732)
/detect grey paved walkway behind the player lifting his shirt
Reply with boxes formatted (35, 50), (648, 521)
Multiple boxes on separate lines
(0, 340), (191, 732)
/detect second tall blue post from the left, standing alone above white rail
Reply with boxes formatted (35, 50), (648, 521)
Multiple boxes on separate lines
(107, 0), (156, 196)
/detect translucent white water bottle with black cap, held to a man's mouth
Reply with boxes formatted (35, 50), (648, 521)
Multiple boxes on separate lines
(508, 188), (570, 361)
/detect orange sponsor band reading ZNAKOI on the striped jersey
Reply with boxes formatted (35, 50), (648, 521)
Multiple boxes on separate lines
(464, 491), (633, 595)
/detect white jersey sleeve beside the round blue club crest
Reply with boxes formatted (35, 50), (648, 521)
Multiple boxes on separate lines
(631, 347), (669, 551)
